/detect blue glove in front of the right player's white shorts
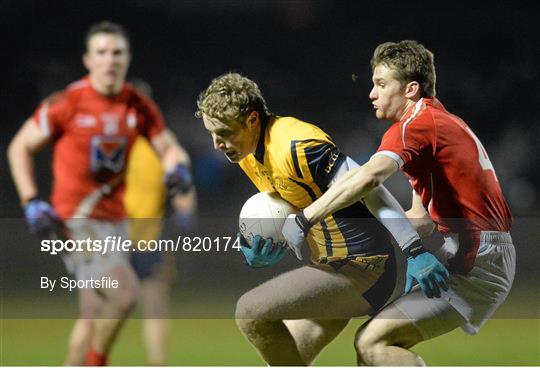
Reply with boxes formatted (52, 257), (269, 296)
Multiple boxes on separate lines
(403, 240), (450, 298)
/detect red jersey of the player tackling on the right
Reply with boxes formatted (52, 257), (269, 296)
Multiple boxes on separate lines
(377, 98), (512, 272)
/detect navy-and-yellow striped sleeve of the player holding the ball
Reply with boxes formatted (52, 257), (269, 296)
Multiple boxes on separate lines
(291, 140), (345, 193)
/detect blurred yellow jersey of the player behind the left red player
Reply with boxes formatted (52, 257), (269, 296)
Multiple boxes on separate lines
(124, 137), (167, 241)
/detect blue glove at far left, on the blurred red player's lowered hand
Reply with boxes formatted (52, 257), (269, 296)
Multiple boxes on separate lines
(24, 198), (63, 236)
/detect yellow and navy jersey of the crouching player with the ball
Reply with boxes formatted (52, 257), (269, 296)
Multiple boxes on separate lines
(240, 117), (391, 263)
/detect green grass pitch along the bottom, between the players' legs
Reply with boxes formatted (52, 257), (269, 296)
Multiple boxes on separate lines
(0, 283), (540, 366)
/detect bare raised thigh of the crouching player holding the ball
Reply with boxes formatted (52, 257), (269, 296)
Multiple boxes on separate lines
(236, 266), (371, 320)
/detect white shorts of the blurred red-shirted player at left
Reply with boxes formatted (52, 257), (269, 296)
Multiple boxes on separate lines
(62, 218), (131, 280)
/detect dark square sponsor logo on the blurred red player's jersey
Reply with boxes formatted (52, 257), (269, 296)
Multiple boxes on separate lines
(90, 135), (128, 180)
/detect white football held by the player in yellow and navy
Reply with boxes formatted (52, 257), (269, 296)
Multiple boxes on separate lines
(238, 192), (298, 245)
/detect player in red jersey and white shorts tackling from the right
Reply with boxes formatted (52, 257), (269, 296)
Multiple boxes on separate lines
(283, 40), (515, 366)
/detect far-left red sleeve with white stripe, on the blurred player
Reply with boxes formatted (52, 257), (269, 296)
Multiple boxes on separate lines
(33, 92), (71, 137)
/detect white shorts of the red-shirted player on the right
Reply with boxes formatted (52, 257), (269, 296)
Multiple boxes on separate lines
(393, 231), (516, 339)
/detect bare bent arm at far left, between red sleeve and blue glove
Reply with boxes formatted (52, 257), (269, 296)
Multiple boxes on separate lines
(7, 118), (49, 206)
